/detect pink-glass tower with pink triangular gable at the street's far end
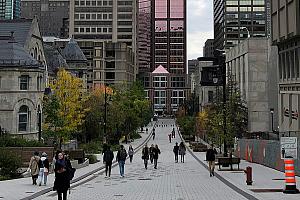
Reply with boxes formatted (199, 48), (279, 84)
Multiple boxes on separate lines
(139, 0), (190, 114)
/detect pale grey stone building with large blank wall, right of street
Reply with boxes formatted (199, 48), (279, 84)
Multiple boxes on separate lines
(226, 38), (278, 132)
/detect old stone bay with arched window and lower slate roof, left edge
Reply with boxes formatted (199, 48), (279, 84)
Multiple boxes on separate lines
(0, 36), (45, 139)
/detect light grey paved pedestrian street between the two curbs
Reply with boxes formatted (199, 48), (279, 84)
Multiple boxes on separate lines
(37, 119), (250, 200)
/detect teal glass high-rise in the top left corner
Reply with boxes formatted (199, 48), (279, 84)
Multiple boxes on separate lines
(0, 0), (21, 19)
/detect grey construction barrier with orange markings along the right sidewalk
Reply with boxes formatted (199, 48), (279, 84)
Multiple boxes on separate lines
(235, 139), (300, 176)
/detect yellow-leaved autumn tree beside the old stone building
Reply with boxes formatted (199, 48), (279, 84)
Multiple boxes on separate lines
(44, 69), (86, 147)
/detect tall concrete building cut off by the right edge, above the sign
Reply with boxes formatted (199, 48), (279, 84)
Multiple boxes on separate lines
(271, 0), (300, 136)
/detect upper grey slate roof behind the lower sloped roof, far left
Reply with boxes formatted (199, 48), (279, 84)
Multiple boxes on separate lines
(0, 19), (32, 46)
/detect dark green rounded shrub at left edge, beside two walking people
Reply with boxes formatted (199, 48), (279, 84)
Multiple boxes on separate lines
(0, 150), (22, 178)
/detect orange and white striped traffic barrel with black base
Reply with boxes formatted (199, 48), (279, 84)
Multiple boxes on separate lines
(283, 158), (299, 194)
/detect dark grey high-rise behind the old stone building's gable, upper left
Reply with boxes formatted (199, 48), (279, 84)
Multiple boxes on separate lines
(21, 0), (69, 38)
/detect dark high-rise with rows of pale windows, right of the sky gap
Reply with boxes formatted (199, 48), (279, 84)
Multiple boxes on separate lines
(214, 0), (270, 49)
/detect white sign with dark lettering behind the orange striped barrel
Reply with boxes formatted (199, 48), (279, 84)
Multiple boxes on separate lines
(280, 137), (297, 160)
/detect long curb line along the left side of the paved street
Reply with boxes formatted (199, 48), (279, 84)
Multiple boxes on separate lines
(20, 122), (157, 200)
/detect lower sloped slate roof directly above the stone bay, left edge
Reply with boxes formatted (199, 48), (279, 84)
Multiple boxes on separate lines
(0, 37), (41, 67)
